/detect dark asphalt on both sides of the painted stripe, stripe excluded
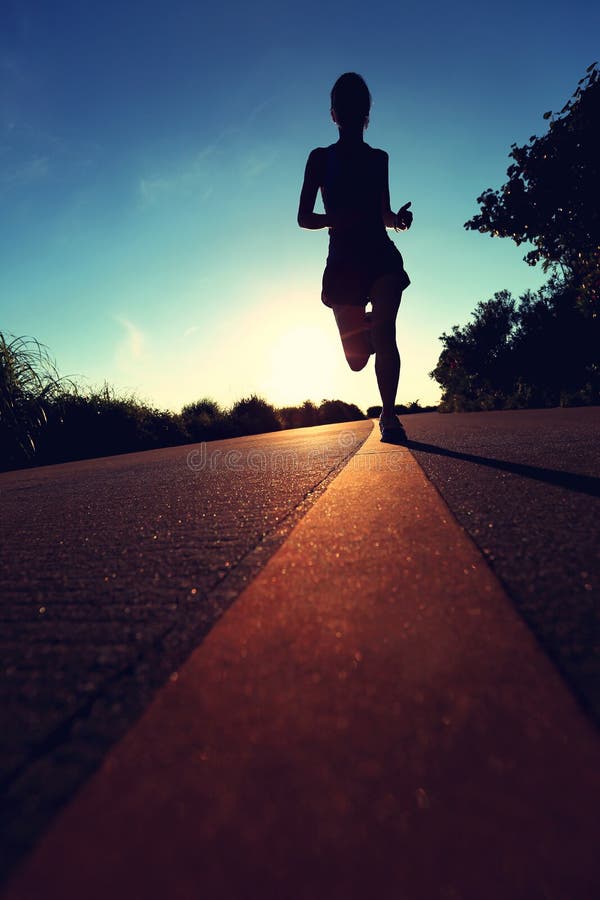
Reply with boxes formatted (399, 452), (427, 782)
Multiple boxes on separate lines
(0, 409), (600, 884)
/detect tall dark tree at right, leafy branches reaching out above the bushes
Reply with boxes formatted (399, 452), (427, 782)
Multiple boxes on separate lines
(465, 63), (600, 311)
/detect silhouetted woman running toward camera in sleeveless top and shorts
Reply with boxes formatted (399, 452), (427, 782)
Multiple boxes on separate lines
(298, 72), (413, 443)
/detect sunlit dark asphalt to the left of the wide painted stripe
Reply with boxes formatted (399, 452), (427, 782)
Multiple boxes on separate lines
(0, 421), (372, 874)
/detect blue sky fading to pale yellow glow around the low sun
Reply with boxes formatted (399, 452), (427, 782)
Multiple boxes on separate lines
(0, 0), (600, 410)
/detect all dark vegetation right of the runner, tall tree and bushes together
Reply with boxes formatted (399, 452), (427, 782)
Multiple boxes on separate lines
(430, 63), (600, 412)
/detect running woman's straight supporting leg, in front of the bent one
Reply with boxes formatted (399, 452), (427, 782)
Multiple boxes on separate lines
(370, 275), (402, 424)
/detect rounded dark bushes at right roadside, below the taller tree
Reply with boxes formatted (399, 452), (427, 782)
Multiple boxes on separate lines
(430, 276), (600, 412)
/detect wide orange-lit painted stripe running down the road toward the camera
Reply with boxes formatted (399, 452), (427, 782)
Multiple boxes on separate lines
(3, 416), (600, 900)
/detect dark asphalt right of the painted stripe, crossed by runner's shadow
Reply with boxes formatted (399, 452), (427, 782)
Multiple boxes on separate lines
(404, 407), (600, 723)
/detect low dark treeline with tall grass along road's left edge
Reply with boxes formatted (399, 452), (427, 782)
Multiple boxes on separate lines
(0, 332), (434, 470)
